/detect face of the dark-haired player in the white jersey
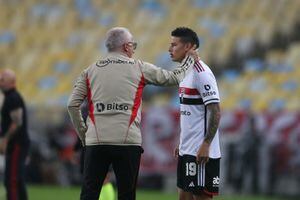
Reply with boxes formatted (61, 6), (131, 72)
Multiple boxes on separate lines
(169, 36), (191, 62)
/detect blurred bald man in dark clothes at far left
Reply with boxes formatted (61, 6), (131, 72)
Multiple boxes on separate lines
(0, 69), (29, 200)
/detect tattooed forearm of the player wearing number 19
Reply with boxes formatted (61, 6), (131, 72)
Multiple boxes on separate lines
(204, 103), (221, 144)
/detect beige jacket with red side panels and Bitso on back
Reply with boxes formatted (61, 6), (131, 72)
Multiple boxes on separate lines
(68, 53), (194, 145)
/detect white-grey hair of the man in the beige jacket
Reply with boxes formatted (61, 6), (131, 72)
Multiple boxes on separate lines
(105, 27), (132, 52)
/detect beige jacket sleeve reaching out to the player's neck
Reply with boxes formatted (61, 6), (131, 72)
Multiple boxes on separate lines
(139, 56), (194, 86)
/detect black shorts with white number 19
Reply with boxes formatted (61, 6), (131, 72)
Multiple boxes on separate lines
(177, 155), (220, 196)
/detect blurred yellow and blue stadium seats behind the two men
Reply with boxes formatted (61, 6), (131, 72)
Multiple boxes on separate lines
(0, 0), (300, 197)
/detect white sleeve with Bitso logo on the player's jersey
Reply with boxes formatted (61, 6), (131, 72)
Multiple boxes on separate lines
(194, 67), (220, 105)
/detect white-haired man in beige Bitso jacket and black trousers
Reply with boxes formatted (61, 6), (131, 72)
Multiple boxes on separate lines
(68, 27), (196, 200)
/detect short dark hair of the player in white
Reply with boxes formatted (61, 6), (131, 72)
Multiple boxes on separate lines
(171, 27), (199, 48)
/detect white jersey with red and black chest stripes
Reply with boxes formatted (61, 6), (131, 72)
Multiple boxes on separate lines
(179, 61), (221, 158)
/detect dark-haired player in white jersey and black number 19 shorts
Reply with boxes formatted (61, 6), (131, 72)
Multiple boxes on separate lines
(169, 27), (221, 200)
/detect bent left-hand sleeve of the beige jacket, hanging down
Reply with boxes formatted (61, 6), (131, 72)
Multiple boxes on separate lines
(68, 70), (87, 145)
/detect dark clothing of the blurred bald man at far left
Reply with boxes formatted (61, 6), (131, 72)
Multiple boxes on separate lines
(1, 89), (29, 200)
